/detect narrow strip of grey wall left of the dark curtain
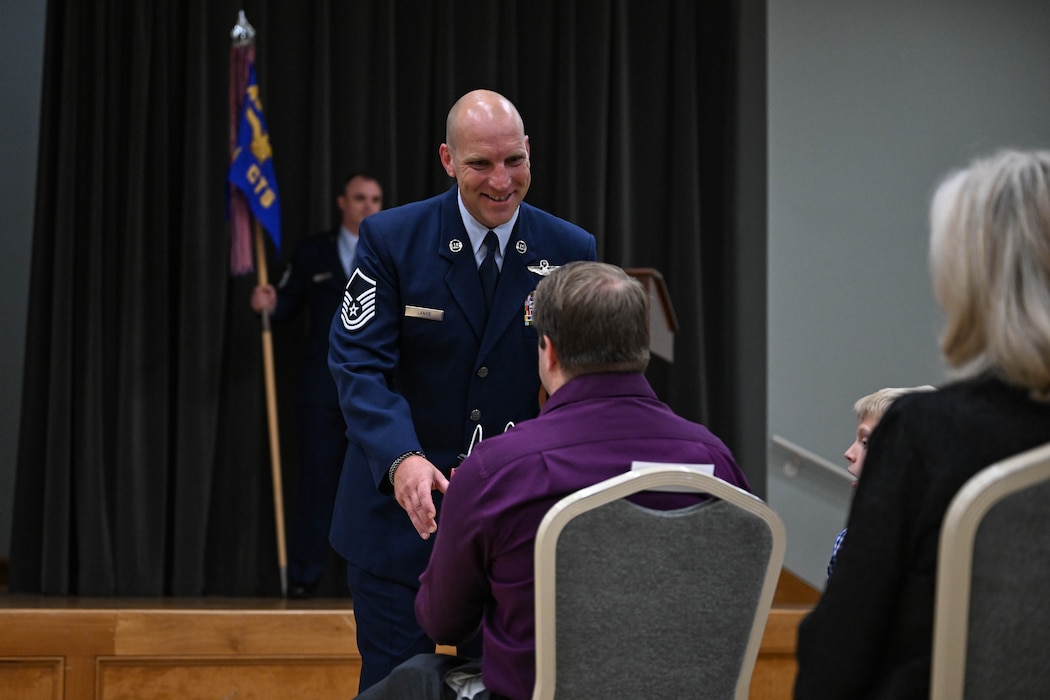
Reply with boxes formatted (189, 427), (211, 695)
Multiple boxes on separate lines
(0, 0), (46, 559)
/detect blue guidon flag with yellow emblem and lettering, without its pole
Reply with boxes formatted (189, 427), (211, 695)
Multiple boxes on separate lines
(228, 62), (280, 253)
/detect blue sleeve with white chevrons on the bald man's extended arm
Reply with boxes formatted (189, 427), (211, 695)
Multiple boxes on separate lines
(329, 220), (420, 489)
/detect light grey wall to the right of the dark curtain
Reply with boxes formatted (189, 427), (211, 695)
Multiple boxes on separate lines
(768, 0), (1050, 587)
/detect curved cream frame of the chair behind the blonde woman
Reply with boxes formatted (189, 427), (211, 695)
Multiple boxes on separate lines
(929, 443), (1050, 700)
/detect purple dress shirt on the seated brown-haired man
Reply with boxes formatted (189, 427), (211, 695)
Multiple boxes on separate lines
(416, 374), (750, 698)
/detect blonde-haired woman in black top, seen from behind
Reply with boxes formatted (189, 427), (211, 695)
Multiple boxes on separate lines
(795, 151), (1050, 700)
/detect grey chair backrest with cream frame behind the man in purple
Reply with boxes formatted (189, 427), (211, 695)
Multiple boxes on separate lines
(532, 466), (785, 700)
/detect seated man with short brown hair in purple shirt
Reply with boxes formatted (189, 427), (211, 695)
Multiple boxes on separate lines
(359, 262), (750, 700)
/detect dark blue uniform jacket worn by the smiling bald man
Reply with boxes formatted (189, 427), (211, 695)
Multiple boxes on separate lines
(329, 187), (597, 587)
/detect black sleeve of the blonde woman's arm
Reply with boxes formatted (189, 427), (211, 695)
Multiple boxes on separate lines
(795, 409), (922, 699)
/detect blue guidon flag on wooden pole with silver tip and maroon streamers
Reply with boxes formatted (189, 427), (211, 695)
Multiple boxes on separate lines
(228, 9), (288, 597)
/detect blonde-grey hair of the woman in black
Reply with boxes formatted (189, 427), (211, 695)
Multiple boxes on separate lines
(929, 150), (1050, 399)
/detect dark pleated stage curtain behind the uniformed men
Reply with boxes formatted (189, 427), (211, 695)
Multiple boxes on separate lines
(9, 0), (738, 596)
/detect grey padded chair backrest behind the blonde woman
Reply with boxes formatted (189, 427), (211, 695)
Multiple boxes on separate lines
(930, 444), (1050, 700)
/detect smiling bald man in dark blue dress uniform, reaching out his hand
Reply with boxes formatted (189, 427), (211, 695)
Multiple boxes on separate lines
(329, 90), (597, 691)
